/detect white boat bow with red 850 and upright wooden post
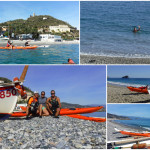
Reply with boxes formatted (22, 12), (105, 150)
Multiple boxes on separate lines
(0, 66), (28, 120)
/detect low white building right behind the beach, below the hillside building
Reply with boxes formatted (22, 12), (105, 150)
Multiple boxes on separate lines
(39, 34), (62, 42)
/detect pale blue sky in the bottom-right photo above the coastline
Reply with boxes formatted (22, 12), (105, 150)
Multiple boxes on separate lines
(107, 104), (150, 118)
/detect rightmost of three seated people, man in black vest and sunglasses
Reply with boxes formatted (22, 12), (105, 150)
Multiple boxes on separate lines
(46, 90), (61, 118)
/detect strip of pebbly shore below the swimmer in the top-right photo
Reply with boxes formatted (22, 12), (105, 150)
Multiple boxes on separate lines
(80, 54), (150, 64)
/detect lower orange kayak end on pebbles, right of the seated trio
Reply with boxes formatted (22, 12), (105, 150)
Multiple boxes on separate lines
(66, 114), (106, 122)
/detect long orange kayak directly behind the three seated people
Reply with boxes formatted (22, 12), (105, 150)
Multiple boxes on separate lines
(11, 106), (103, 117)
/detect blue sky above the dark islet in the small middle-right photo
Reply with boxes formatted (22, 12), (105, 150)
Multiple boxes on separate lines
(107, 65), (150, 78)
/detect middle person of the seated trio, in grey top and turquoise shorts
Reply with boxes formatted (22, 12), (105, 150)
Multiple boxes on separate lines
(39, 91), (49, 117)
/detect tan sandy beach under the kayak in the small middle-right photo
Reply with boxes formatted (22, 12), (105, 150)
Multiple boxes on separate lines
(107, 84), (150, 103)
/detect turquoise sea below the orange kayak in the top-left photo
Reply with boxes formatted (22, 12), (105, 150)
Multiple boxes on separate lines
(0, 44), (79, 64)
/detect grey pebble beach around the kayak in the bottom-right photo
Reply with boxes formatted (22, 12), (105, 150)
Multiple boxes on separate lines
(107, 119), (146, 143)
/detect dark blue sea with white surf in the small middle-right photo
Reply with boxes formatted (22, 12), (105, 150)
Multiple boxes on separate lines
(107, 78), (150, 87)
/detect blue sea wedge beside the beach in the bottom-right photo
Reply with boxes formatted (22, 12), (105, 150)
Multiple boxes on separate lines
(115, 117), (150, 131)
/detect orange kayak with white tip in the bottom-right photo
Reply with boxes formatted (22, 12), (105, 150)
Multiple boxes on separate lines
(115, 128), (150, 137)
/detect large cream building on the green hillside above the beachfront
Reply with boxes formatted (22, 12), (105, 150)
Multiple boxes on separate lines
(49, 25), (70, 32)
